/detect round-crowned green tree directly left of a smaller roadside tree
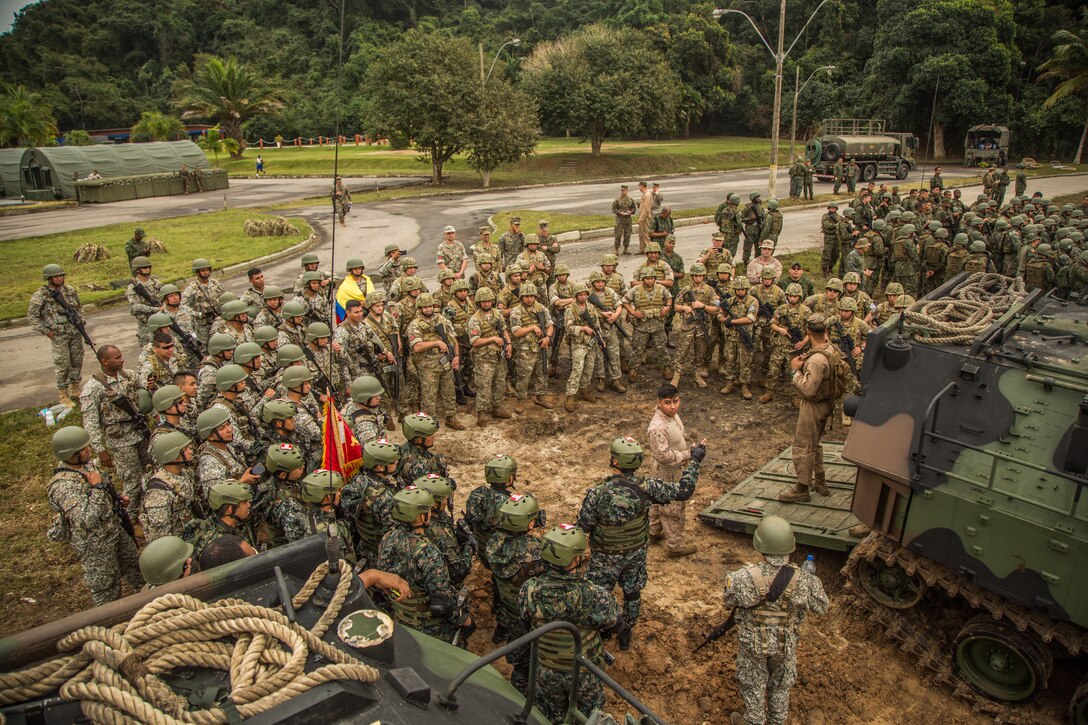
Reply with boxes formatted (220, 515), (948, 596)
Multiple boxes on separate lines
(363, 28), (481, 185)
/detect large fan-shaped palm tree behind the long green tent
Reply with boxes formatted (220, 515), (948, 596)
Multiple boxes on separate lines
(178, 57), (283, 156)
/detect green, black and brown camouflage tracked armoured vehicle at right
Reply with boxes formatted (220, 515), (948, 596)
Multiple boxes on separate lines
(842, 272), (1088, 723)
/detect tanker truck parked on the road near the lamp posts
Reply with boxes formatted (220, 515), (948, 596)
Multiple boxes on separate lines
(805, 119), (918, 183)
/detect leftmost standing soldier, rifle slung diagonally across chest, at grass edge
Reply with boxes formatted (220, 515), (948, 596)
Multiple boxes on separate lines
(26, 265), (85, 408)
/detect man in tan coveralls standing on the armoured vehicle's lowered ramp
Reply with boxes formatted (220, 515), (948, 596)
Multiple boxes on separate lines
(778, 312), (848, 502)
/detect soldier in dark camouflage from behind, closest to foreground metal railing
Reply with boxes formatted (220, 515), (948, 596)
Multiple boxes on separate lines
(518, 524), (622, 723)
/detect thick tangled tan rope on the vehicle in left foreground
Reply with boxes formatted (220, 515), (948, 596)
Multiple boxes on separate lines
(0, 561), (380, 725)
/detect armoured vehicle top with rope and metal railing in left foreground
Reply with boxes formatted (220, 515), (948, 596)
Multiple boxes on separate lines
(0, 536), (664, 725)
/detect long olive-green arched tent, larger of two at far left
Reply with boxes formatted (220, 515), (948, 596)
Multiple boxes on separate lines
(18, 140), (209, 199)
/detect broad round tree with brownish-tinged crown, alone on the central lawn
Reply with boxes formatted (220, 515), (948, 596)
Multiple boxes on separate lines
(522, 25), (680, 156)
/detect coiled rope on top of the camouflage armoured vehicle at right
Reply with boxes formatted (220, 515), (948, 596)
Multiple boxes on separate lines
(903, 272), (1027, 345)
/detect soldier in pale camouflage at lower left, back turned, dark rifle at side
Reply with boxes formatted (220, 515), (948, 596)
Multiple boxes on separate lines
(47, 426), (144, 606)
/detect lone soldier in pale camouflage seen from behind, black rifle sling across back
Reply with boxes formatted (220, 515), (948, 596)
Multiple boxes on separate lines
(725, 516), (830, 725)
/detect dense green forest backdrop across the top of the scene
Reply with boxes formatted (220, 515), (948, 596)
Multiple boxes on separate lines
(0, 0), (1088, 159)
